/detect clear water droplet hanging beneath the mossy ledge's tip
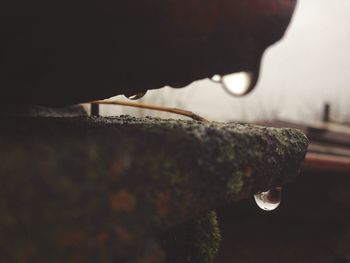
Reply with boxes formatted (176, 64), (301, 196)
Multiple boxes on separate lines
(254, 187), (282, 211)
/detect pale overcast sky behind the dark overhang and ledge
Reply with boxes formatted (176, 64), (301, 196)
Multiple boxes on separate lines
(104, 0), (350, 122)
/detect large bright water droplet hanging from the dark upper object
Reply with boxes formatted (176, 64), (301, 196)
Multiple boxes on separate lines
(221, 71), (257, 96)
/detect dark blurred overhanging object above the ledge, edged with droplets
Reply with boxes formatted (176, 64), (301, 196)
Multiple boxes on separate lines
(0, 0), (296, 105)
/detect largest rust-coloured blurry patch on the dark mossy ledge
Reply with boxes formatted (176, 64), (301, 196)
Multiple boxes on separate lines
(110, 190), (136, 212)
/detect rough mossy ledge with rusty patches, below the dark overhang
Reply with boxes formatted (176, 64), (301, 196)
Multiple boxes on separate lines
(0, 116), (308, 262)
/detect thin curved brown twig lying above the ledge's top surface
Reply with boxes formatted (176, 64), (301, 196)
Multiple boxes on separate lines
(90, 100), (209, 122)
